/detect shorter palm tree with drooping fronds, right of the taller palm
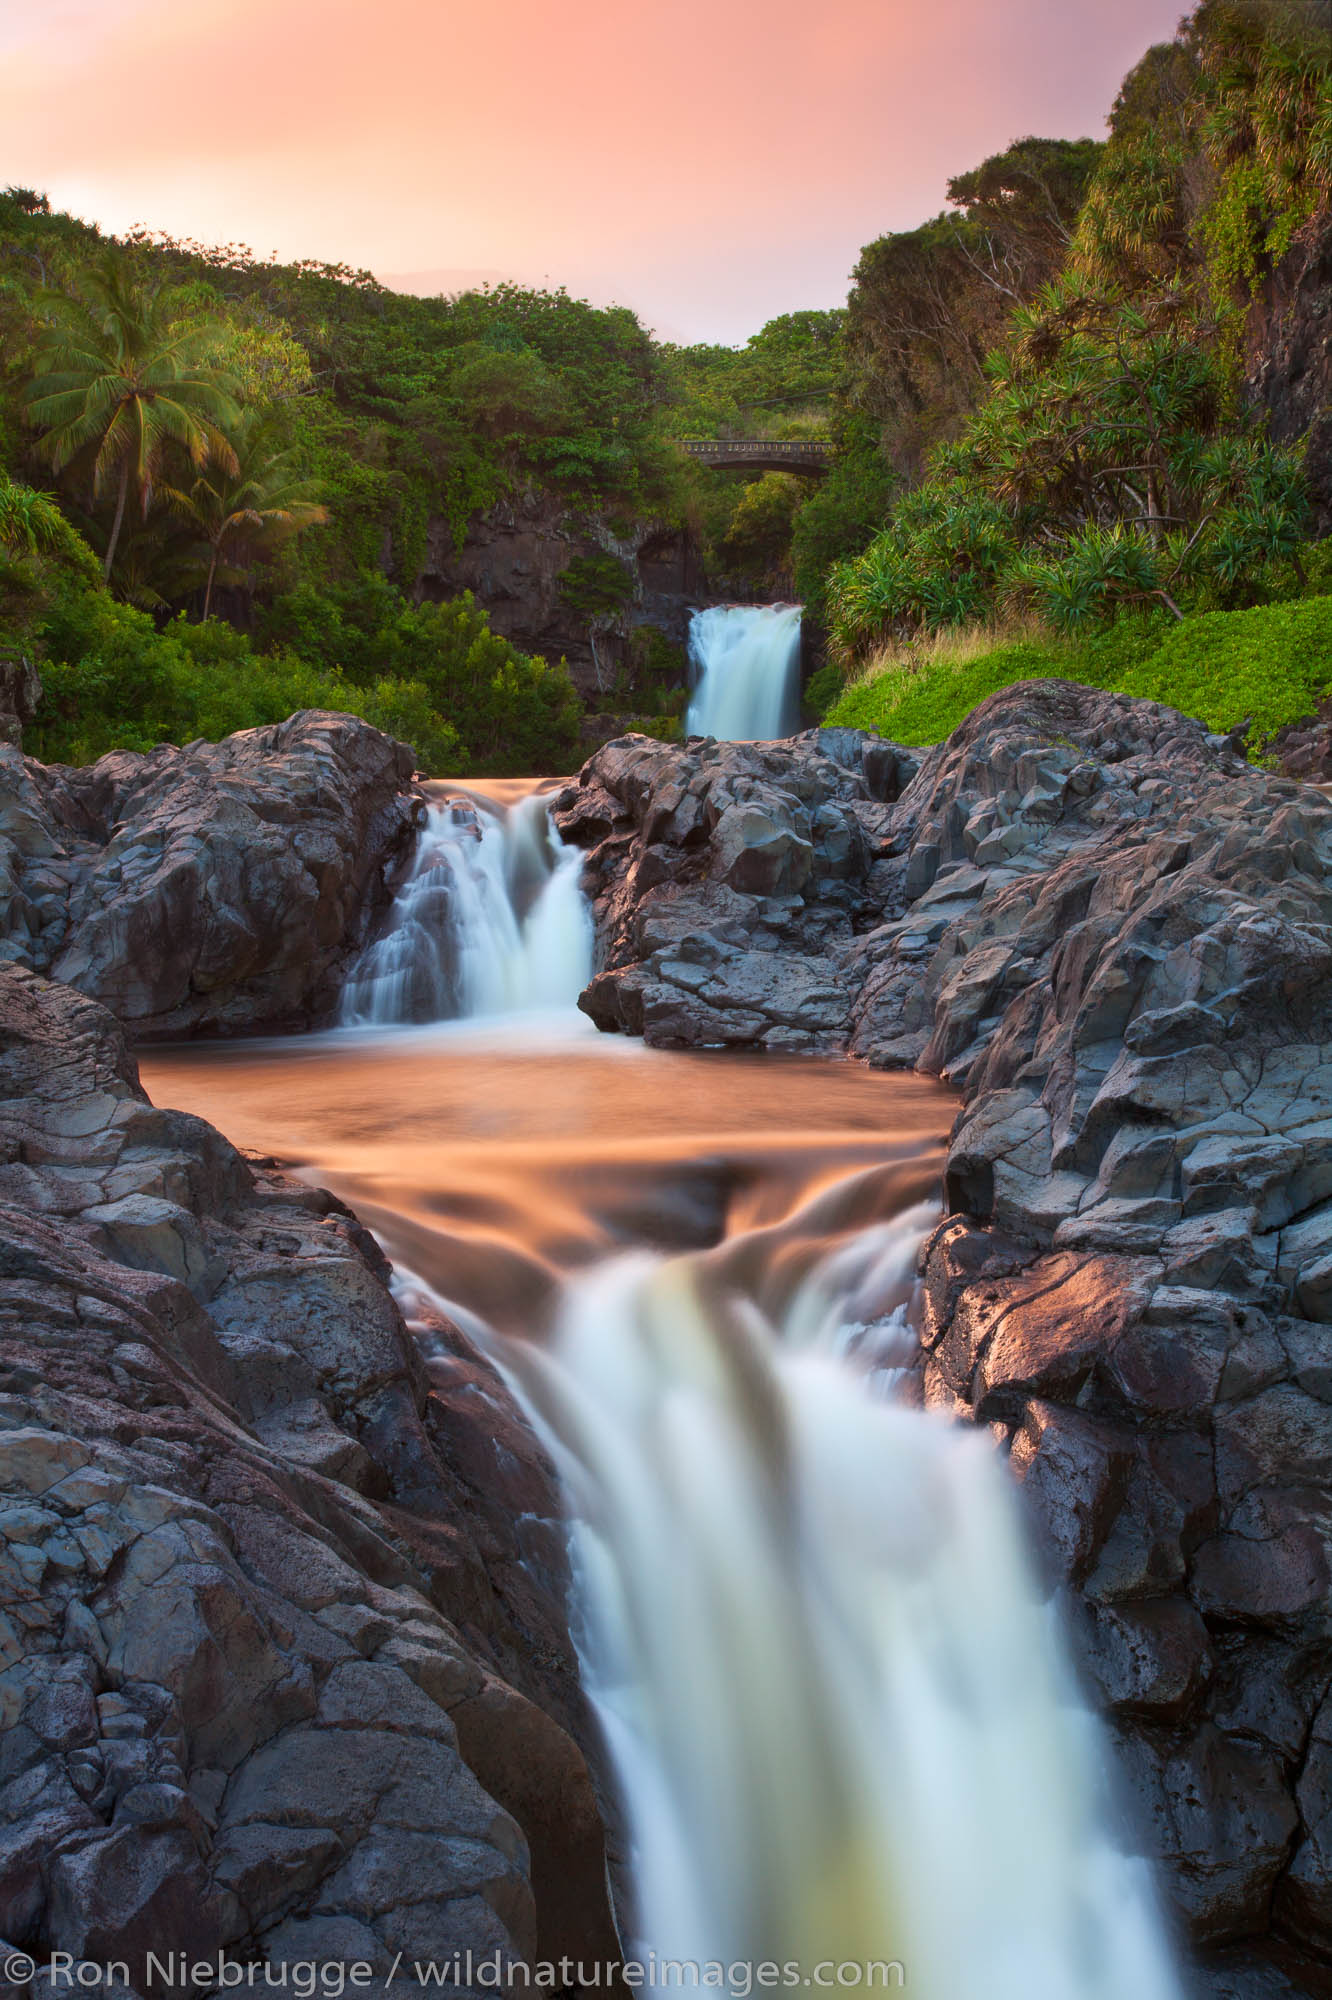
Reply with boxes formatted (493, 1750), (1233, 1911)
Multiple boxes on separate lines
(166, 410), (328, 618)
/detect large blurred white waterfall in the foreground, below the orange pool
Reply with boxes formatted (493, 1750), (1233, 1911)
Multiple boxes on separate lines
(472, 1182), (1180, 2000)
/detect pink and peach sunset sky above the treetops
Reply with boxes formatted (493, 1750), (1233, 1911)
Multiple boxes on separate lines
(0, 0), (1180, 342)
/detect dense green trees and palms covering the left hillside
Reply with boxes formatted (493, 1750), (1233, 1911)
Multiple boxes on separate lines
(0, 203), (640, 772)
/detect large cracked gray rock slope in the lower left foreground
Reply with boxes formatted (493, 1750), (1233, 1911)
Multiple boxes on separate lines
(0, 966), (608, 1992)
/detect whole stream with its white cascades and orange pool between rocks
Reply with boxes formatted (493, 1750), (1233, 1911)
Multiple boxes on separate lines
(142, 608), (1178, 2000)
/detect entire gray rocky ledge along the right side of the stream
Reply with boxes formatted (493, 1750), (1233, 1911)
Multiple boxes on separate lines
(556, 680), (1332, 1996)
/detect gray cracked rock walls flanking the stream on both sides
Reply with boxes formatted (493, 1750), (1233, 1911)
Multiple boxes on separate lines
(0, 682), (1332, 2000)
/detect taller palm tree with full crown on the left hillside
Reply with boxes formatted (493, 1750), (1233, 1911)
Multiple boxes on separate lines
(28, 256), (240, 582)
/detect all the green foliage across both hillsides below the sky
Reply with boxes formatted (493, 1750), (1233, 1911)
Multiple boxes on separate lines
(0, 0), (1332, 772)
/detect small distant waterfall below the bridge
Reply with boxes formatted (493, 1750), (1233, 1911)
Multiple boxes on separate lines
(686, 604), (800, 742)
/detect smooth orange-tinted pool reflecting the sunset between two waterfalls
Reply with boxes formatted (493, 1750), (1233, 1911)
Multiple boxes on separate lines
(140, 1016), (954, 1334)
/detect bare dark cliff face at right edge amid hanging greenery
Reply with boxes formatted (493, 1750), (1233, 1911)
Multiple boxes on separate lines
(1244, 214), (1332, 534)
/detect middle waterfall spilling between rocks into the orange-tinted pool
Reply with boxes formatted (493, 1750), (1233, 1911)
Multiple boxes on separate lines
(342, 790), (592, 1026)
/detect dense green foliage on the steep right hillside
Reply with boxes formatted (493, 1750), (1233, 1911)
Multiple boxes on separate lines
(826, 0), (1332, 666)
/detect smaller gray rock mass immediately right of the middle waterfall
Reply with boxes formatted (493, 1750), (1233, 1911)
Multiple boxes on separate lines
(554, 730), (916, 1052)
